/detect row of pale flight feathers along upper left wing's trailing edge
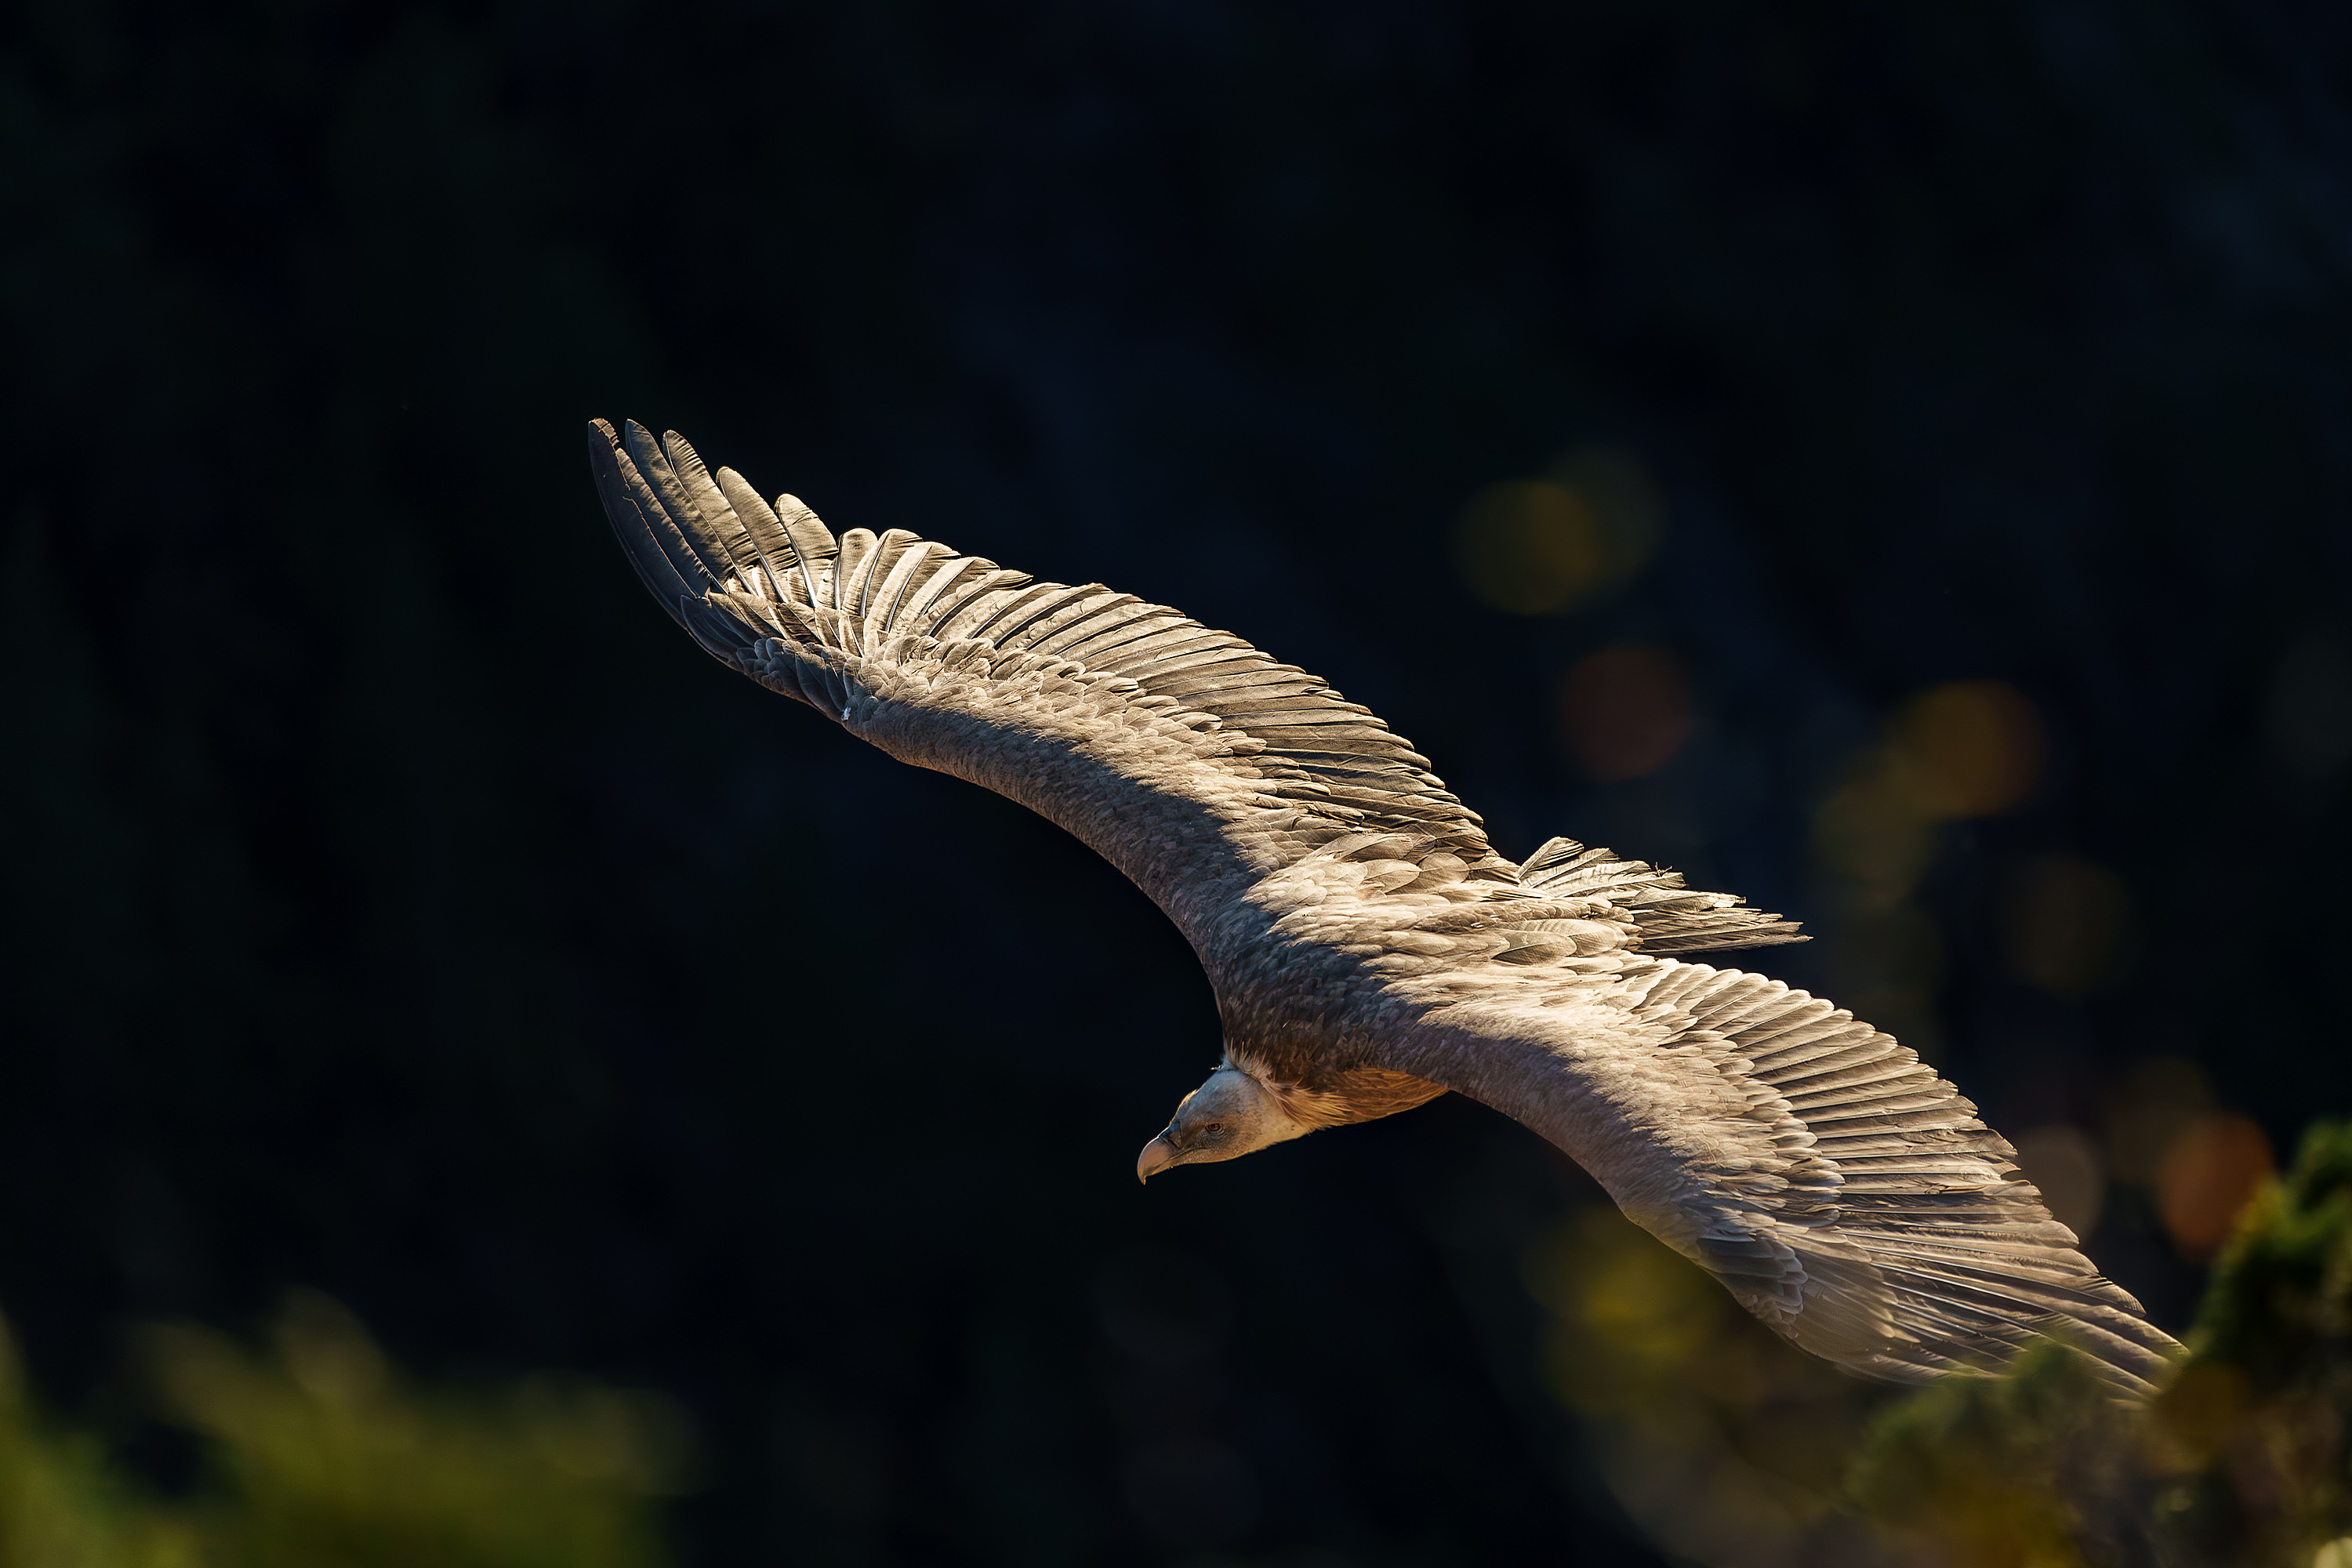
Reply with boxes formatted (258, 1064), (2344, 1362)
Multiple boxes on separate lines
(588, 421), (1505, 869)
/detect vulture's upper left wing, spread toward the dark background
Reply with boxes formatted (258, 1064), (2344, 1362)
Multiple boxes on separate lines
(588, 421), (1515, 935)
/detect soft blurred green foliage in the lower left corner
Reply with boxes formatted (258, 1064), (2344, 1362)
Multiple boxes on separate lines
(0, 1295), (682, 1568)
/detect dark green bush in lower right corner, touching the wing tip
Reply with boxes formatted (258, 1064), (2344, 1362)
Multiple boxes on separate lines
(1853, 1121), (2352, 1568)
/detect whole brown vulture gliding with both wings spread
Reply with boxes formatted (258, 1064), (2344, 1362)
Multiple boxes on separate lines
(588, 421), (2176, 1396)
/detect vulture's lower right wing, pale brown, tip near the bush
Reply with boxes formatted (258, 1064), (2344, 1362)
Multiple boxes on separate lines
(1381, 959), (2176, 1394)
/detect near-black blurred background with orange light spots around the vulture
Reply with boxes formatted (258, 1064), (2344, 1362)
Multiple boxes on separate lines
(0, 0), (2352, 1568)
